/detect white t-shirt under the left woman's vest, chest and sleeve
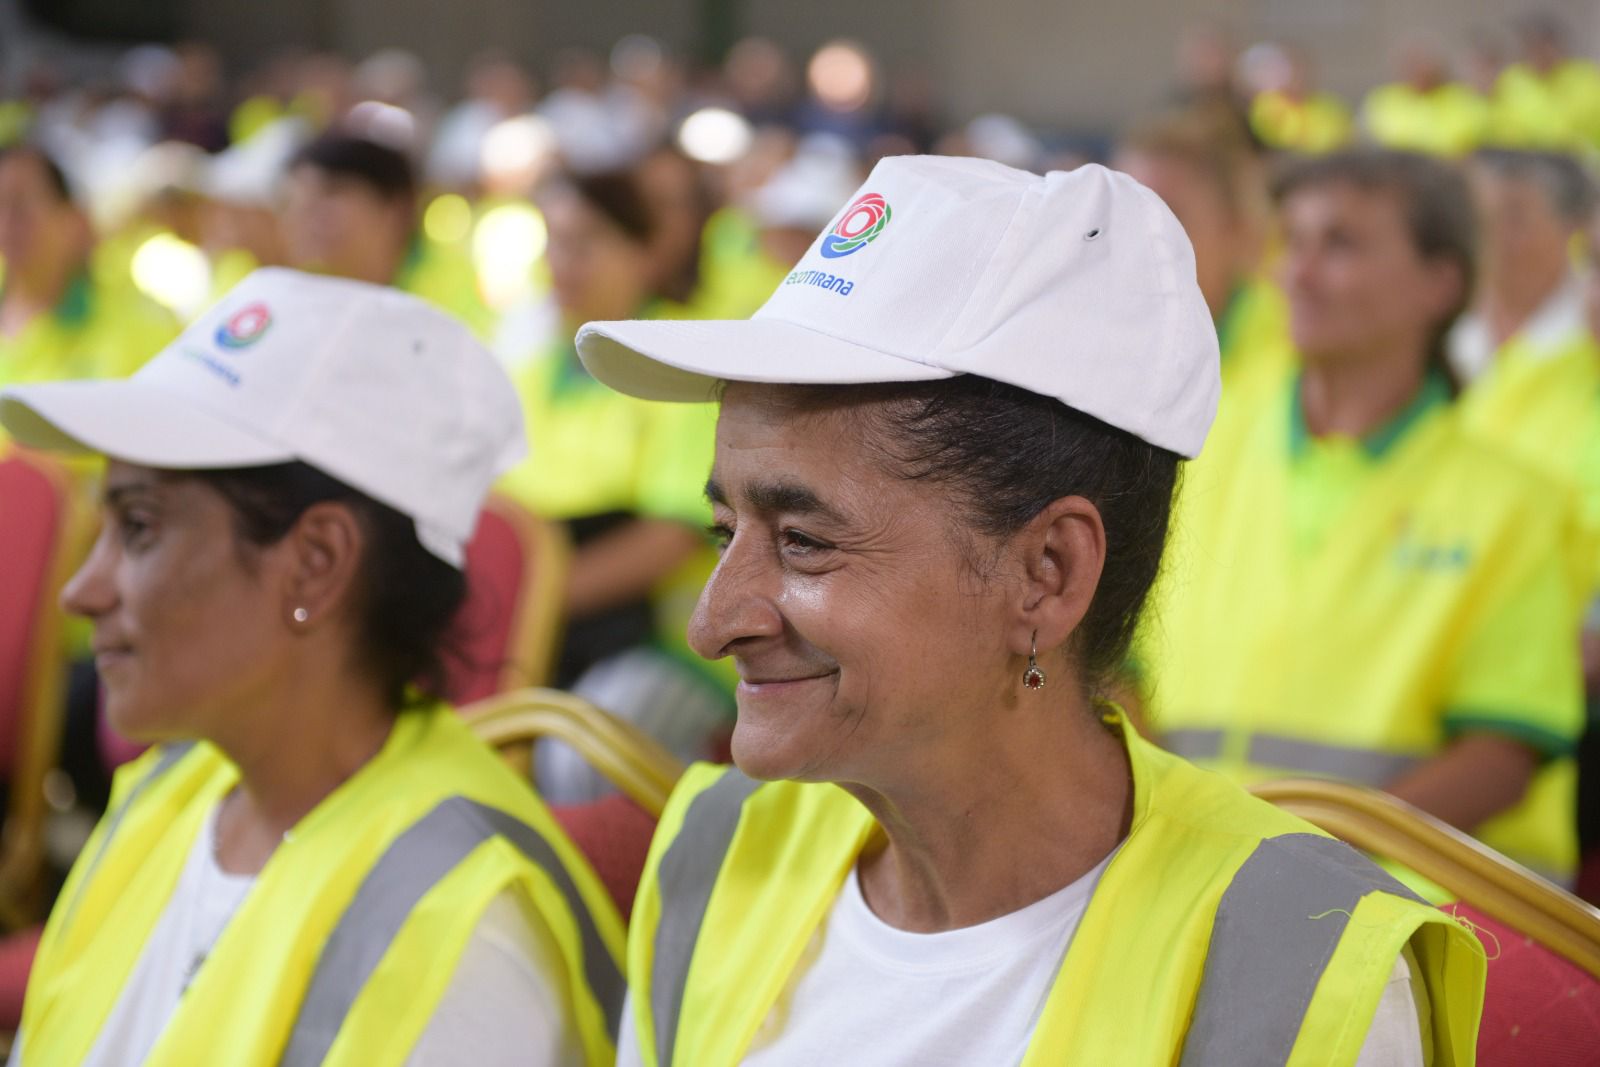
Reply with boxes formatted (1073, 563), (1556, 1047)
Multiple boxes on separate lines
(11, 799), (582, 1067)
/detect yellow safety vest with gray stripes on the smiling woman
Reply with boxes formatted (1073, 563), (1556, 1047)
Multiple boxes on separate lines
(626, 720), (1485, 1067)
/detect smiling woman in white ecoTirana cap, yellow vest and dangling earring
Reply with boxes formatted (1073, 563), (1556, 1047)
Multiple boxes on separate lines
(578, 157), (1483, 1067)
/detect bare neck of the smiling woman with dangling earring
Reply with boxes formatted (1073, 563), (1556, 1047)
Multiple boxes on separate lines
(845, 699), (1133, 933)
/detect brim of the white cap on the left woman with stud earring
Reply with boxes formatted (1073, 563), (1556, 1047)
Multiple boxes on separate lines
(0, 379), (294, 470)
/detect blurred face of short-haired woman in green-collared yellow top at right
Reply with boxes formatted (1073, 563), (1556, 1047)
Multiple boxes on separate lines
(1280, 181), (1462, 363)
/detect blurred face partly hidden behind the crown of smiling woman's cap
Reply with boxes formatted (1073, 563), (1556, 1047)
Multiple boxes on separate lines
(1115, 149), (1256, 318)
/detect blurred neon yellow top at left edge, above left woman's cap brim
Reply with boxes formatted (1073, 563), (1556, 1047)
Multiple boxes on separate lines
(0, 274), (178, 386)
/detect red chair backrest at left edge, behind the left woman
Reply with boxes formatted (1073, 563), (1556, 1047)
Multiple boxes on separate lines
(0, 454), (67, 774)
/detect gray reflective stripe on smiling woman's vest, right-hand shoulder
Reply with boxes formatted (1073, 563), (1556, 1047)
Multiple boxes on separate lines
(1179, 833), (1421, 1067)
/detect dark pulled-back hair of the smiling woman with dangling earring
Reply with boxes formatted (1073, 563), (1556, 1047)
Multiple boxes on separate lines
(780, 374), (1179, 694)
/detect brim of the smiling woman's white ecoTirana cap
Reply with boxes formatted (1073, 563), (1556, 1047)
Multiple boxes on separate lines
(578, 318), (954, 400)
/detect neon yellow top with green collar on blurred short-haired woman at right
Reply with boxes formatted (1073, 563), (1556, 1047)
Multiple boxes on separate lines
(1139, 367), (1582, 878)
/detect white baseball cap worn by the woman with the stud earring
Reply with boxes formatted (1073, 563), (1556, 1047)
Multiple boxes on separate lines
(0, 267), (526, 566)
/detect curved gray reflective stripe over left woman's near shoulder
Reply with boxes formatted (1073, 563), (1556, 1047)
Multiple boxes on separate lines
(278, 797), (626, 1067)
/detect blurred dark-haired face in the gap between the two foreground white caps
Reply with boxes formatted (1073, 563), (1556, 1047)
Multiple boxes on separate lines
(541, 187), (654, 326)
